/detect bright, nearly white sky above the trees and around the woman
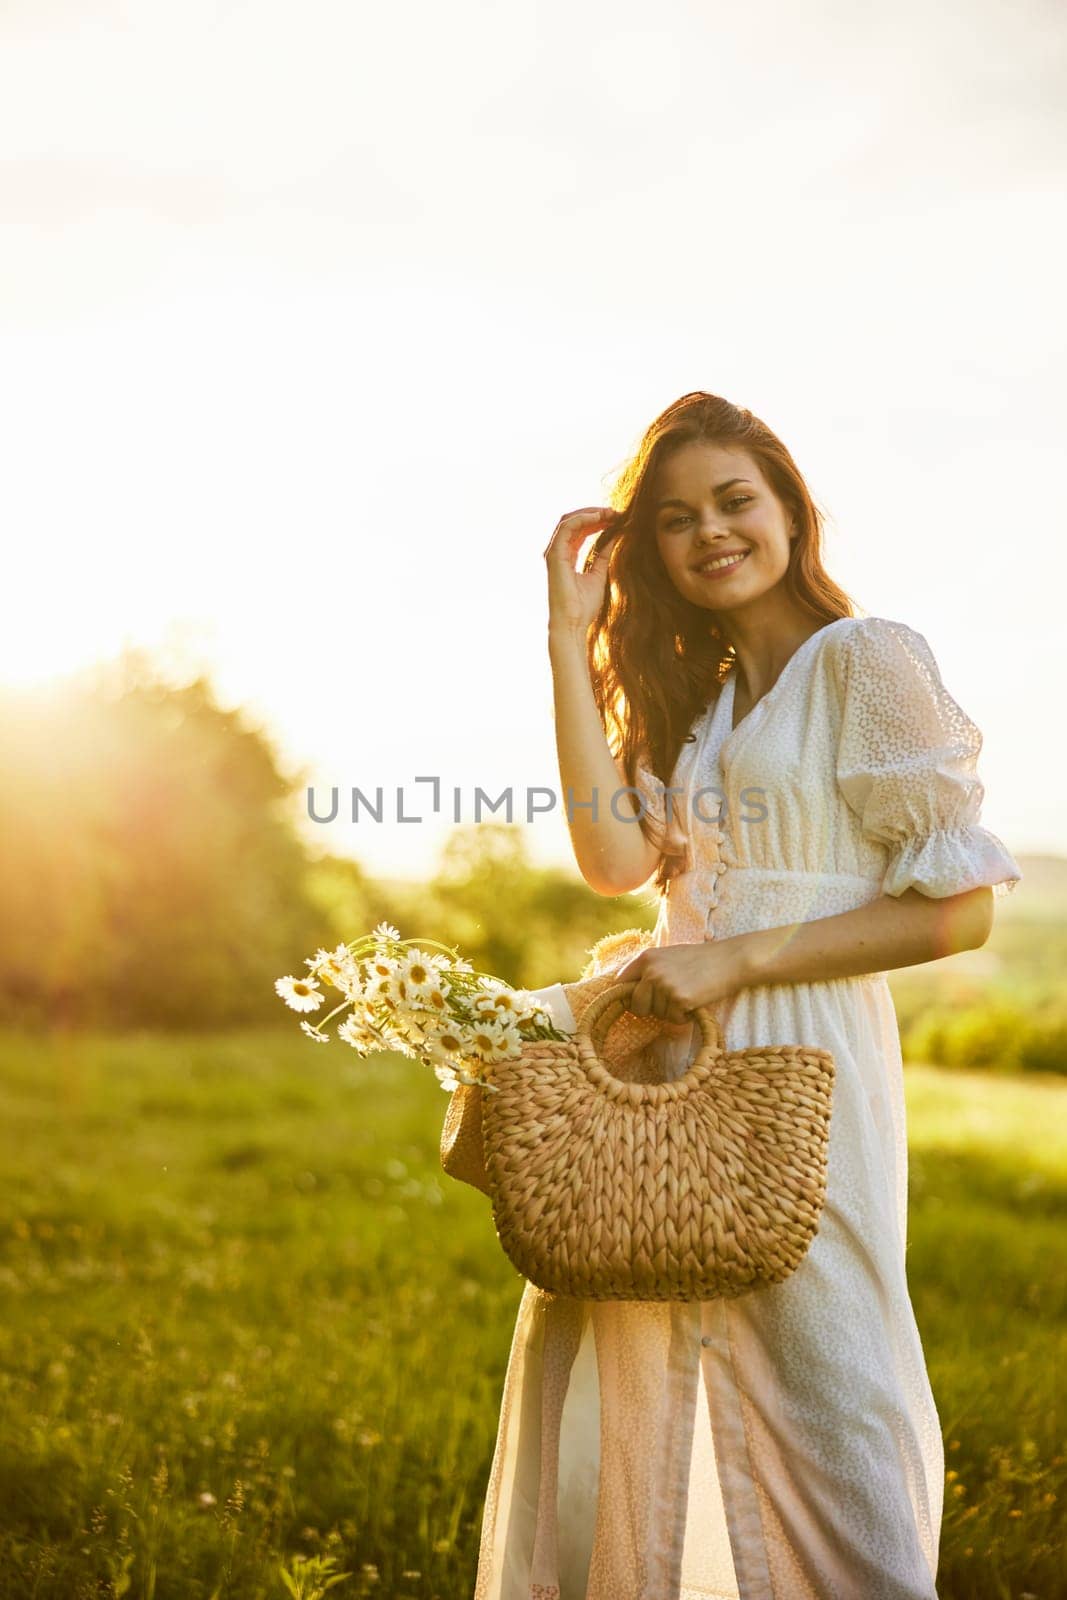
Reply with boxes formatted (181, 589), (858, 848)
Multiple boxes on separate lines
(0, 0), (1067, 875)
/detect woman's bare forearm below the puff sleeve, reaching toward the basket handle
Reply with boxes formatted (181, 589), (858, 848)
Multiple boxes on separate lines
(735, 885), (993, 987)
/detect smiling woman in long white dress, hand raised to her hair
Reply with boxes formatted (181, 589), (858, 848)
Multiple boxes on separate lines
(475, 394), (1021, 1600)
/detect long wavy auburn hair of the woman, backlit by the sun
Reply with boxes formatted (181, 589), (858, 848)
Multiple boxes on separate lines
(587, 390), (856, 893)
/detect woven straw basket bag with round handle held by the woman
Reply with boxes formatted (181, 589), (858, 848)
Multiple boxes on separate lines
(451, 982), (833, 1301)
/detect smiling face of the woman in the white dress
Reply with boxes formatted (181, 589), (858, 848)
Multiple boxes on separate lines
(654, 443), (790, 611)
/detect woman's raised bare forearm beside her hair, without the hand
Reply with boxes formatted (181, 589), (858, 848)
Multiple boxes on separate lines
(549, 624), (659, 894)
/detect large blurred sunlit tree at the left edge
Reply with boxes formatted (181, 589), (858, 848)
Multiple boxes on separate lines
(0, 651), (322, 1027)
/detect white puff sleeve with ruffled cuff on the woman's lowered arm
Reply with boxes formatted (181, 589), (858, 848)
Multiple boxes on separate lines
(837, 618), (1022, 899)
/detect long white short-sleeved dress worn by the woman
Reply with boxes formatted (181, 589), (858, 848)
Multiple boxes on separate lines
(474, 616), (1022, 1600)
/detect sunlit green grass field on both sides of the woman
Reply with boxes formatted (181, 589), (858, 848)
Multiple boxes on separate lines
(0, 1024), (1067, 1600)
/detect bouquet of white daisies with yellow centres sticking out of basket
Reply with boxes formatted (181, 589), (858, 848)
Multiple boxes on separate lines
(274, 922), (569, 1093)
